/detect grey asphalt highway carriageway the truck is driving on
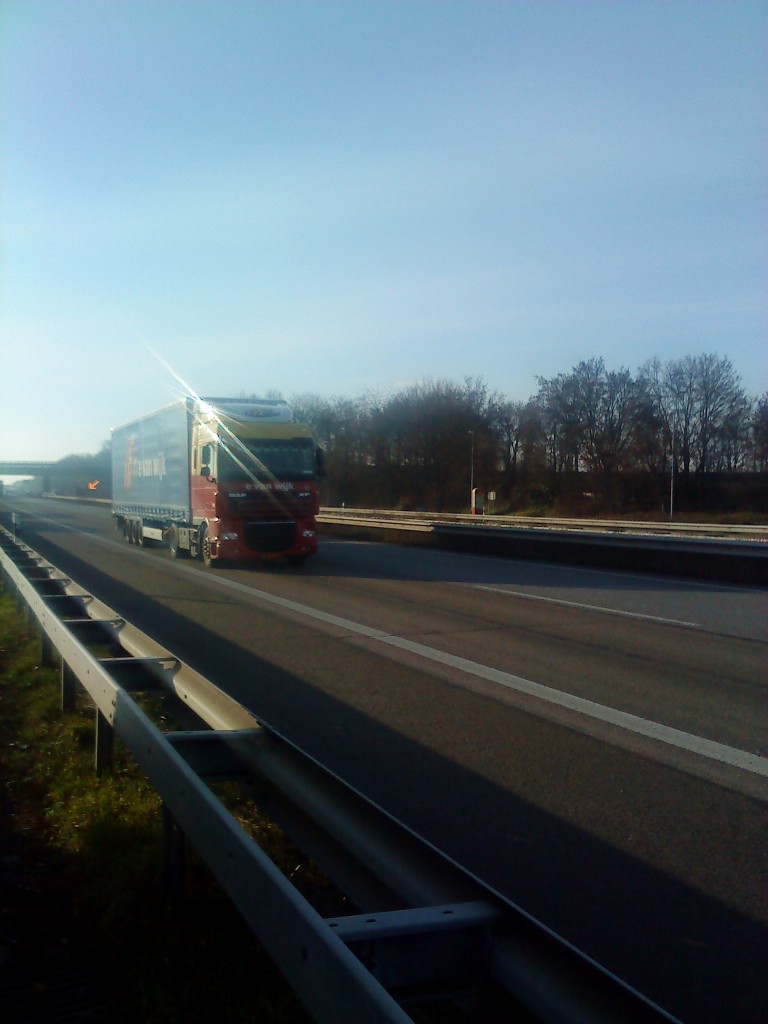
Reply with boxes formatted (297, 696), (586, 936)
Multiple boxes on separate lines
(5, 498), (768, 1024)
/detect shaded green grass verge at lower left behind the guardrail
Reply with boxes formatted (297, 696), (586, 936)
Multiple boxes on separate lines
(0, 591), (309, 1024)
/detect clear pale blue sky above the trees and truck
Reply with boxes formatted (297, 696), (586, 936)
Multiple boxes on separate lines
(0, 0), (768, 459)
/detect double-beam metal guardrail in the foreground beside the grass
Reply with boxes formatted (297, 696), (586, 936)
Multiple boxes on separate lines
(0, 527), (675, 1024)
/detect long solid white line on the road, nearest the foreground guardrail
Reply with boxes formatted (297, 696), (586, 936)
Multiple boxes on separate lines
(182, 565), (768, 778)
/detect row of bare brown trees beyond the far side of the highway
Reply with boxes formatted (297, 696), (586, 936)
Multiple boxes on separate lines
(290, 354), (768, 512)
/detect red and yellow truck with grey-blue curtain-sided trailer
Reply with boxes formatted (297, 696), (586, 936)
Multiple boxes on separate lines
(112, 397), (325, 567)
